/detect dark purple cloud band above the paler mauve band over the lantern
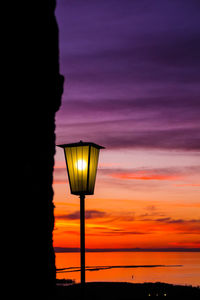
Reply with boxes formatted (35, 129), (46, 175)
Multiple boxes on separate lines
(57, 96), (200, 119)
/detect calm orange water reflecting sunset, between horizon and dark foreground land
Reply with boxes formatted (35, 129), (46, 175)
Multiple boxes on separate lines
(56, 252), (200, 286)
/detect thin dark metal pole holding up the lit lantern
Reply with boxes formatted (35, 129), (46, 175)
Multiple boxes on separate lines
(80, 194), (85, 286)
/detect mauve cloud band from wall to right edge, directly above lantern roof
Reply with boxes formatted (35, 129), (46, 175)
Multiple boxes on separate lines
(55, 120), (200, 151)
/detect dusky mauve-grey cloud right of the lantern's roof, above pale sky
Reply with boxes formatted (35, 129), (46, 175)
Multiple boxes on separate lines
(101, 128), (200, 151)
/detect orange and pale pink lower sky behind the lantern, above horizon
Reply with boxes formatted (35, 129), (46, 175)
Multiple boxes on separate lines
(53, 149), (200, 249)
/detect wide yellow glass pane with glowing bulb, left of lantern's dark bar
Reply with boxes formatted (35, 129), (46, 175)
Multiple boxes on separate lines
(65, 146), (89, 195)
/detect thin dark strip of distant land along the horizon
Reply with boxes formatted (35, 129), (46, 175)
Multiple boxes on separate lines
(54, 247), (200, 253)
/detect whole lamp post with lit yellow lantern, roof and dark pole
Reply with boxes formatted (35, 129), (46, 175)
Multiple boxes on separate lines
(58, 141), (104, 286)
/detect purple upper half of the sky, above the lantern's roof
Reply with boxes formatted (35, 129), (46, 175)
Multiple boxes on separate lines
(56, 0), (200, 151)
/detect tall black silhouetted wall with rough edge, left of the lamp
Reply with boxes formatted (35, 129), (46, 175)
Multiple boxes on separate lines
(4, 0), (64, 299)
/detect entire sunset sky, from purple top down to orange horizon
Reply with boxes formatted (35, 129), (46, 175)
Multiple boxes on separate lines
(53, 0), (200, 249)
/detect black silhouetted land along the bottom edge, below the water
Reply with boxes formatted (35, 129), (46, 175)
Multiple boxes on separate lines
(56, 282), (200, 300)
